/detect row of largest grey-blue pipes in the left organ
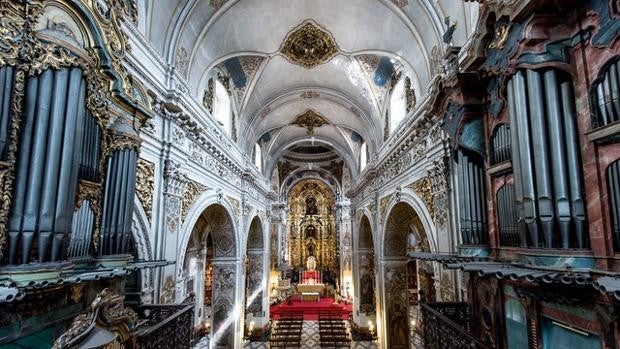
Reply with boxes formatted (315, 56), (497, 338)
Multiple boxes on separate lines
(9, 68), (85, 264)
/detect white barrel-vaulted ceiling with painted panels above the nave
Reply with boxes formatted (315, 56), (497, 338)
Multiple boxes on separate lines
(139, 0), (477, 176)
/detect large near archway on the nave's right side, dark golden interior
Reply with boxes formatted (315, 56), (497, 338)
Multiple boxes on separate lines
(382, 202), (434, 349)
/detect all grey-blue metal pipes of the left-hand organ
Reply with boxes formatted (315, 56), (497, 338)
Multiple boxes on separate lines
(0, 67), (137, 265)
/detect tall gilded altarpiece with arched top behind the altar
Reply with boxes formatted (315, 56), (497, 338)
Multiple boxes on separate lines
(287, 180), (339, 271)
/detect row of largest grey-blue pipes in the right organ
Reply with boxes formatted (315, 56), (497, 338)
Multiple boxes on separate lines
(507, 70), (586, 248)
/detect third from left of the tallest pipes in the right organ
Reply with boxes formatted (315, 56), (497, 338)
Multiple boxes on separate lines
(544, 70), (571, 248)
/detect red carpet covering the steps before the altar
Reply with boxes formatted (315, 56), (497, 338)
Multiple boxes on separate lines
(270, 298), (353, 320)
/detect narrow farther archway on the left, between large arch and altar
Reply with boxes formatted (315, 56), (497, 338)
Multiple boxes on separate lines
(244, 217), (267, 335)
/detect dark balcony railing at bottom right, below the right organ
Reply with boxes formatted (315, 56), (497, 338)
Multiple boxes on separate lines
(420, 303), (489, 349)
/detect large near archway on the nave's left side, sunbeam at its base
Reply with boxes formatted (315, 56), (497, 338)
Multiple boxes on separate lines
(183, 204), (239, 348)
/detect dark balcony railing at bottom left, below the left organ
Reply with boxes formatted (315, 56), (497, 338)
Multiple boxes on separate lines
(127, 304), (194, 349)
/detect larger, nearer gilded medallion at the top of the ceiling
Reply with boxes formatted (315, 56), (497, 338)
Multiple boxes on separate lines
(280, 21), (338, 68)
